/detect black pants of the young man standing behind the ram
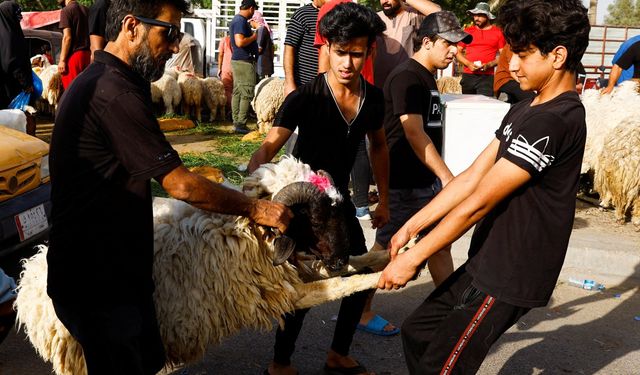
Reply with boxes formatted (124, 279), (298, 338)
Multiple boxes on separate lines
(273, 201), (369, 366)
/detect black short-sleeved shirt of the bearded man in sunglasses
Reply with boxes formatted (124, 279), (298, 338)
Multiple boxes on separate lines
(47, 51), (181, 303)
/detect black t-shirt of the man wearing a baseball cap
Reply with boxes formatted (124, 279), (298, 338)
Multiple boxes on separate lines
(384, 59), (442, 189)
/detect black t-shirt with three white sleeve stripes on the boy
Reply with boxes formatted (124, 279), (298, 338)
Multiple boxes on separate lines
(467, 92), (586, 307)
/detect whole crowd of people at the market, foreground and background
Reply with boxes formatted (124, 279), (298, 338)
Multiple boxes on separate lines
(0, 0), (624, 375)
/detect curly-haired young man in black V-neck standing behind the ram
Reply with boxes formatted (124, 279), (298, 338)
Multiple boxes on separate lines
(249, 2), (389, 375)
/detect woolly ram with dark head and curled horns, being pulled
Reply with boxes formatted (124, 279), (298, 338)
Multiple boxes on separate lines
(16, 158), (388, 374)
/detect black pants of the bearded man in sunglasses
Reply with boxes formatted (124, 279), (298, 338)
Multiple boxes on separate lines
(53, 296), (165, 375)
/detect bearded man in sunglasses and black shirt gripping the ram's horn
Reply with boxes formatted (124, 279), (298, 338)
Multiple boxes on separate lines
(47, 0), (291, 374)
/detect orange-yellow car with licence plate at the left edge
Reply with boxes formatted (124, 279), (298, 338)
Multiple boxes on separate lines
(0, 119), (51, 258)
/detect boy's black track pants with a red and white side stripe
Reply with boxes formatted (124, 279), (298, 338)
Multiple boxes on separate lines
(401, 265), (530, 375)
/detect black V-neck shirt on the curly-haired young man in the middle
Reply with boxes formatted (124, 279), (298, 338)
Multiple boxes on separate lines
(274, 74), (384, 197)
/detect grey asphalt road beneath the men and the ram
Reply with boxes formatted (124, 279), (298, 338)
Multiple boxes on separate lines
(0, 262), (640, 375)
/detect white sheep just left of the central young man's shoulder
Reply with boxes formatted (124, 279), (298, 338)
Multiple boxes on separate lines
(251, 77), (285, 134)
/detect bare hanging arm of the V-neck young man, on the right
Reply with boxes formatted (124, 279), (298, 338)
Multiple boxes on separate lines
(367, 128), (389, 228)
